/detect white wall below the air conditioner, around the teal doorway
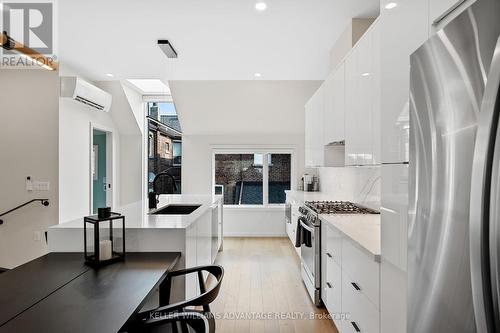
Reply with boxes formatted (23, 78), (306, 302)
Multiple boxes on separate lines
(59, 68), (143, 222)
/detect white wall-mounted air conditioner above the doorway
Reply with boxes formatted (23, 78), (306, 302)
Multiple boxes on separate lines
(61, 76), (113, 112)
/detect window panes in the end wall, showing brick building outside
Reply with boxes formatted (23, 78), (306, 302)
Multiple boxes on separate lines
(214, 152), (292, 205)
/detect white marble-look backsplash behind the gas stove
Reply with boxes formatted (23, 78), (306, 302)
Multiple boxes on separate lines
(318, 166), (381, 210)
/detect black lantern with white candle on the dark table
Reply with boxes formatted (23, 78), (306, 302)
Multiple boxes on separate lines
(83, 213), (125, 267)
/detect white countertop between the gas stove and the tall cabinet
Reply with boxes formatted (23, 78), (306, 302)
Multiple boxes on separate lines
(319, 214), (380, 262)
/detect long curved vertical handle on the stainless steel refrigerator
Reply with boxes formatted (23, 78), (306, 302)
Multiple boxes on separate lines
(469, 38), (500, 333)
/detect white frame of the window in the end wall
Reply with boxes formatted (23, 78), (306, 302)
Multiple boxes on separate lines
(211, 146), (296, 209)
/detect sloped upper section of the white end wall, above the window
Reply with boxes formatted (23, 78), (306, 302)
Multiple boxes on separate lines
(170, 80), (321, 135)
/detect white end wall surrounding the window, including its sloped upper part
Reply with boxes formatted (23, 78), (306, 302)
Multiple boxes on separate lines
(170, 80), (321, 236)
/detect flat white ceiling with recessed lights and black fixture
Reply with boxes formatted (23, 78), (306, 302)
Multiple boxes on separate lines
(57, 0), (379, 80)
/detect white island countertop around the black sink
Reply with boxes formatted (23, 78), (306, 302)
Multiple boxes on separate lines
(51, 194), (222, 229)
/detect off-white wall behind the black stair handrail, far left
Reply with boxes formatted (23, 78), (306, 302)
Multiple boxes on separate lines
(0, 69), (59, 268)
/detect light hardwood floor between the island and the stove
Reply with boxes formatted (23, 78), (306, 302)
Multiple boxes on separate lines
(212, 238), (337, 333)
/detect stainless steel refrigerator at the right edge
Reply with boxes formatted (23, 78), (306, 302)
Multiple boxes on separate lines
(407, 0), (500, 333)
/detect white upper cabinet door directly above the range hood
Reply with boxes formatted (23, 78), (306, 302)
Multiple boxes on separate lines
(323, 62), (345, 145)
